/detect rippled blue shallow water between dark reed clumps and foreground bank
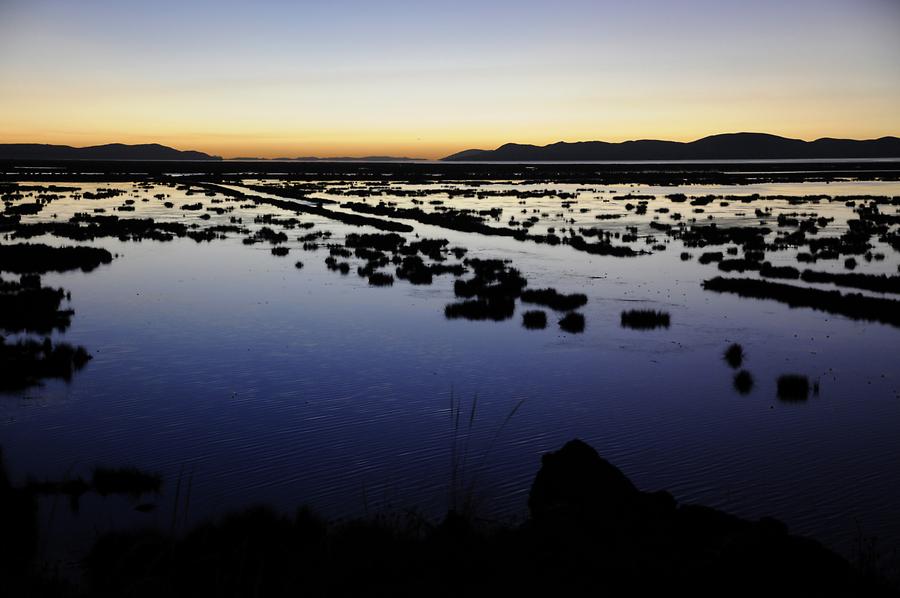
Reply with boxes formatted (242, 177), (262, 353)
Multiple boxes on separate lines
(0, 181), (900, 568)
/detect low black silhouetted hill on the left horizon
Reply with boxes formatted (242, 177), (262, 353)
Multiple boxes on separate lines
(0, 143), (222, 160)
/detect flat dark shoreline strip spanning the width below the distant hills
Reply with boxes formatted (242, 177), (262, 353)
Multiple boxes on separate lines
(0, 160), (900, 185)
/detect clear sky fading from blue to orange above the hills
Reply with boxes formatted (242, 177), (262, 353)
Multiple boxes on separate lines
(0, 0), (900, 157)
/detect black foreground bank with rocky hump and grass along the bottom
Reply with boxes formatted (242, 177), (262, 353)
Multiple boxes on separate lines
(0, 440), (897, 598)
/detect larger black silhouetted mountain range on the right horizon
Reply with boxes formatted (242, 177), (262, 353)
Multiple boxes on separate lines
(442, 133), (900, 162)
